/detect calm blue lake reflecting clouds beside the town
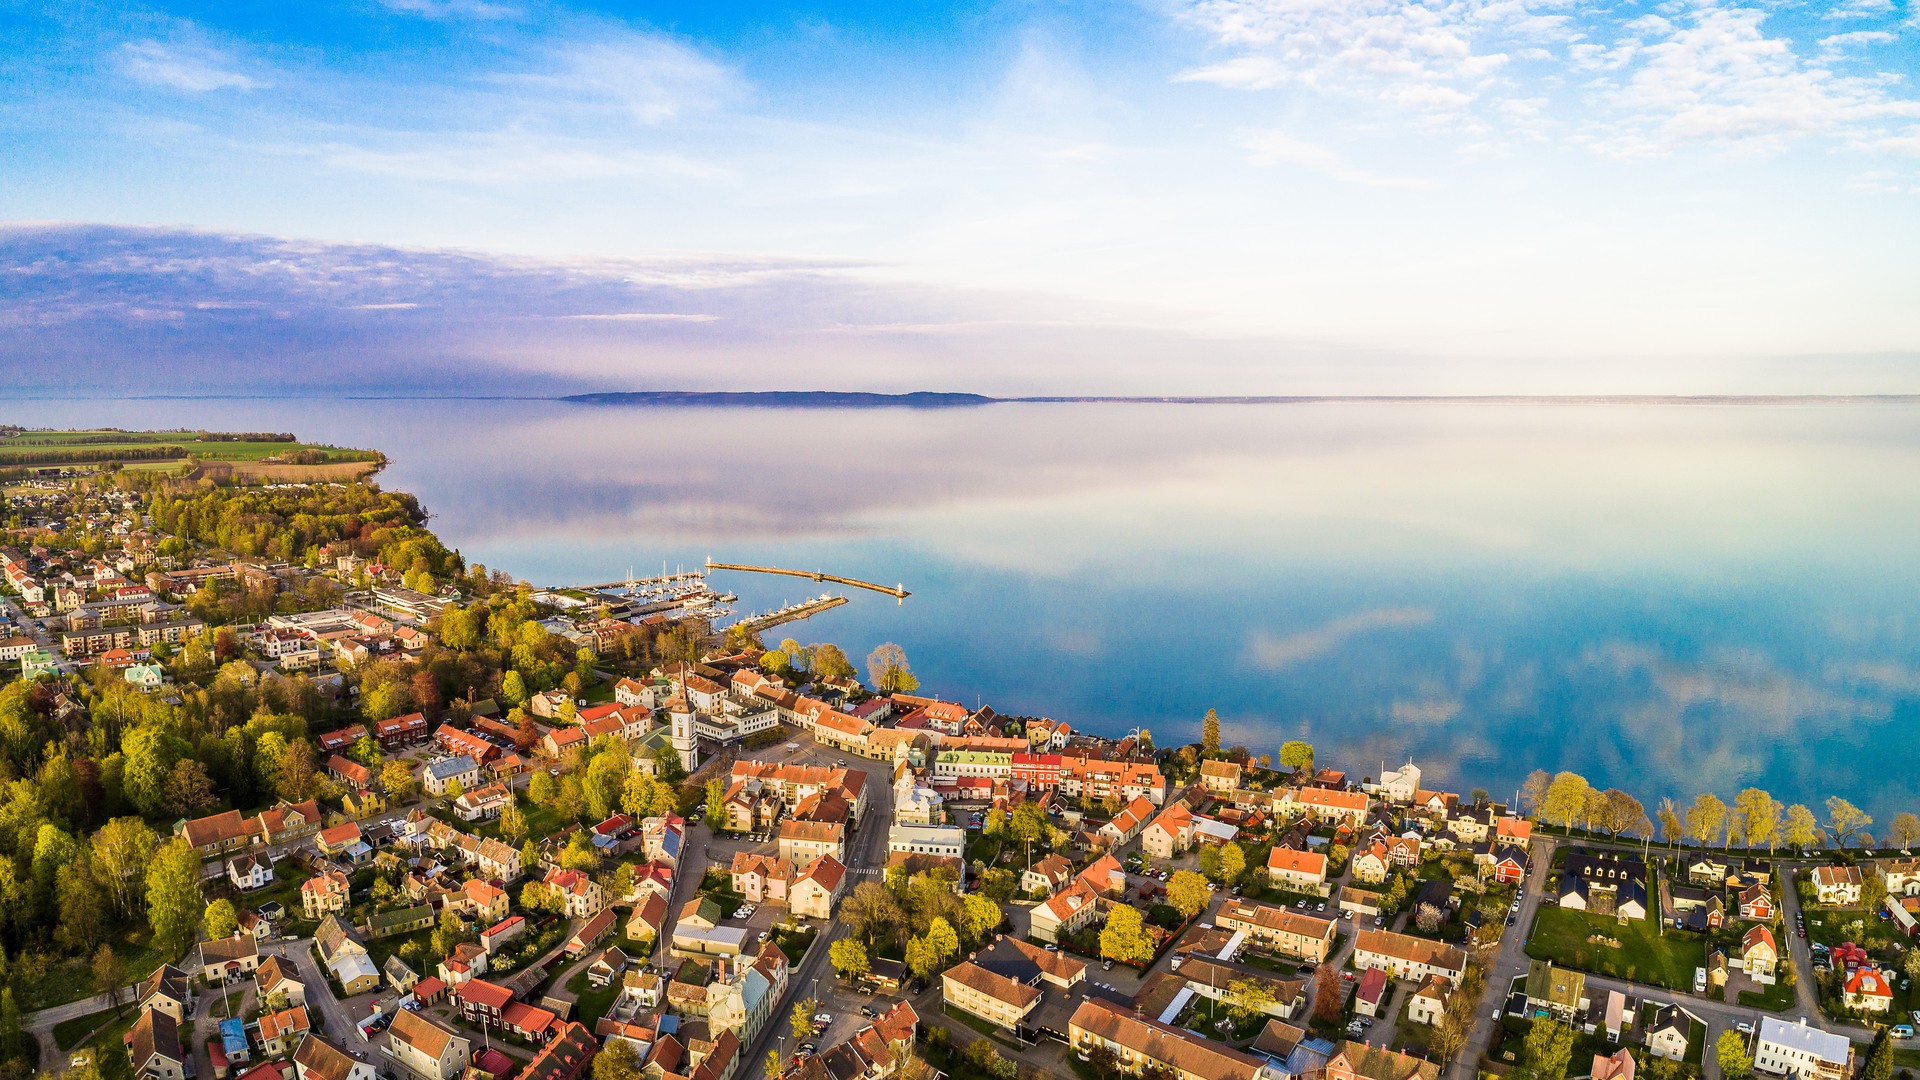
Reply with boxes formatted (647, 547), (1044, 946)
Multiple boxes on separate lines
(0, 400), (1920, 814)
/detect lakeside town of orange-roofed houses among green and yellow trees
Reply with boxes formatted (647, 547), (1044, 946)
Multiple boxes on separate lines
(0, 432), (1920, 1080)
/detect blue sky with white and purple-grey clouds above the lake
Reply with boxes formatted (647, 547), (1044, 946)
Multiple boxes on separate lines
(0, 0), (1920, 394)
